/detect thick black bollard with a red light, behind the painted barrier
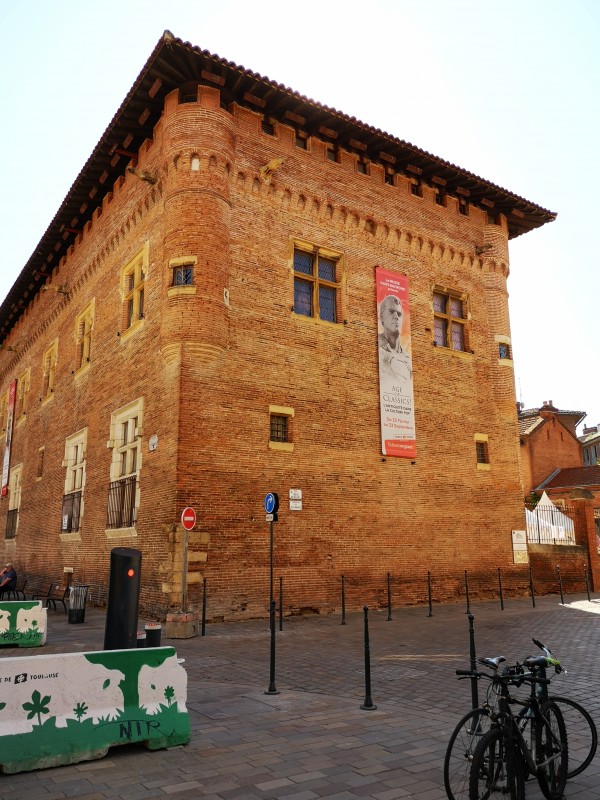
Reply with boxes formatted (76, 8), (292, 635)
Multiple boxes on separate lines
(104, 547), (142, 650)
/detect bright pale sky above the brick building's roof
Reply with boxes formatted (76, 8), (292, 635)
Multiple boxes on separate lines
(0, 0), (600, 432)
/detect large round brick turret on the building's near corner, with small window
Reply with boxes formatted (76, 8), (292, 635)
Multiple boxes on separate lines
(161, 86), (235, 365)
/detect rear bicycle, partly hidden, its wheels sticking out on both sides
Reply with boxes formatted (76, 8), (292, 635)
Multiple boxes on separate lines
(444, 639), (598, 800)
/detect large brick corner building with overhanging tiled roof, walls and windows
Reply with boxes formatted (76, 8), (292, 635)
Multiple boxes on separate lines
(0, 32), (554, 618)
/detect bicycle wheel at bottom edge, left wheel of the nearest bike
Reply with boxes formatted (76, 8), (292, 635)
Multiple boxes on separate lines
(469, 727), (525, 800)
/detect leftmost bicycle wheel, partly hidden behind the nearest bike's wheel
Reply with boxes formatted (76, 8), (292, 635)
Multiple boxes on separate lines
(444, 708), (491, 800)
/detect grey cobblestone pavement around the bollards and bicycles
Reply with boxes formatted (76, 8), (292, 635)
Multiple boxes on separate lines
(0, 595), (600, 800)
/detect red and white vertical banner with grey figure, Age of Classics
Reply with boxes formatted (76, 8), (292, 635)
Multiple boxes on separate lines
(375, 267), (417, 458)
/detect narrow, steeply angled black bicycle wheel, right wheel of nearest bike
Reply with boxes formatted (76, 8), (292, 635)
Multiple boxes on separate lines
(532, 700), (569, 800)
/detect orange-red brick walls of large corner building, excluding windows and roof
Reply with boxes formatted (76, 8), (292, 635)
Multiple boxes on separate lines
(0, 84), (548, 618)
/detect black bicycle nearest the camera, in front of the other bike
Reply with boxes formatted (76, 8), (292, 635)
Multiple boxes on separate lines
(469, 656), (568, 800)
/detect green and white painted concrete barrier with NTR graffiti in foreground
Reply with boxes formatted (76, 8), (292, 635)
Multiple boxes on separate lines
(0, 647), (190, 773)
